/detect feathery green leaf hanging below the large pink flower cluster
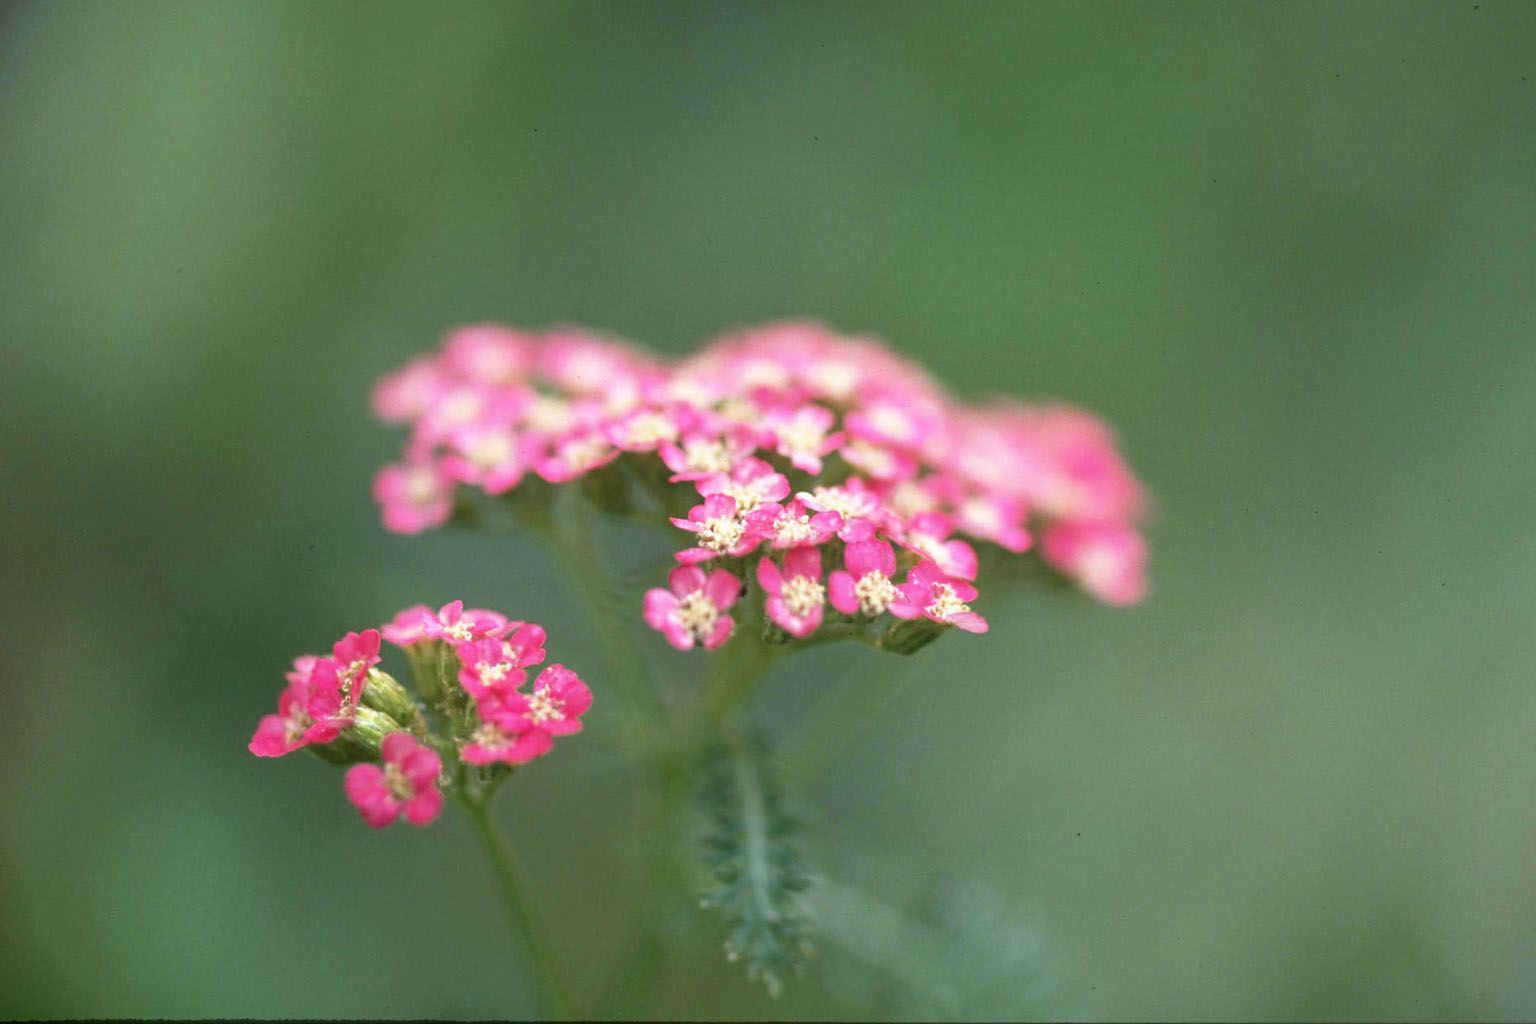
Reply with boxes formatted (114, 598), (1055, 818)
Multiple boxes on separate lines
(700, 737), (811, 996)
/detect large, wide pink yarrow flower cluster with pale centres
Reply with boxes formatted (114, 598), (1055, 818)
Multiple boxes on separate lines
(373, 322), (1147, 648)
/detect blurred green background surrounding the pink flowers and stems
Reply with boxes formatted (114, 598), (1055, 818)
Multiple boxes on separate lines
(0, 0), (1536, 1019)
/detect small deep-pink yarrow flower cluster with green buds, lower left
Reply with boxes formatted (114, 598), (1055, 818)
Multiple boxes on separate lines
(249, 600), (591, 827)
